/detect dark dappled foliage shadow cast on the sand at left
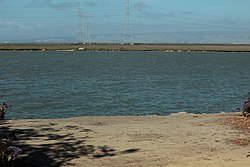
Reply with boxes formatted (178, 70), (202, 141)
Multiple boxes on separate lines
(0, 120), (140, 167)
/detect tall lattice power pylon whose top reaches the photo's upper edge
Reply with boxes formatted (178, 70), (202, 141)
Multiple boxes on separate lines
(122, 0), (134, 45)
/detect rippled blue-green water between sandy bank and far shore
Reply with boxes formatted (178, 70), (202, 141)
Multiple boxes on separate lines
(0, 52), (250, 119)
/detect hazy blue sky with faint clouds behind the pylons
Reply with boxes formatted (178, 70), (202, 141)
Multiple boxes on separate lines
(0, 0), (250, 43)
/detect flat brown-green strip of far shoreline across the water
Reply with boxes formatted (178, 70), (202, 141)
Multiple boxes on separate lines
(0, 43), (250, 52)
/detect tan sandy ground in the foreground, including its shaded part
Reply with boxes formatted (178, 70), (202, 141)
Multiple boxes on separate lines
(0, 113), (250, 167)
